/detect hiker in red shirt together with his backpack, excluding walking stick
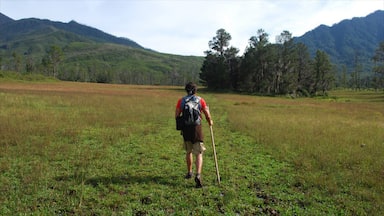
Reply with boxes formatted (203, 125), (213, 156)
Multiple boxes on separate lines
(175, 82), (213, 188)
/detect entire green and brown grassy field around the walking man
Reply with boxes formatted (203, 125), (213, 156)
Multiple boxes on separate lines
(0, 79), (384, 215)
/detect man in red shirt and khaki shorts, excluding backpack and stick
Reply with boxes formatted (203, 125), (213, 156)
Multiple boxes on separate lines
(175, 82), (213, 188)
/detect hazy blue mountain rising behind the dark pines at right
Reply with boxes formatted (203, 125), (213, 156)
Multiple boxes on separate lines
(294, 10), (384, 71)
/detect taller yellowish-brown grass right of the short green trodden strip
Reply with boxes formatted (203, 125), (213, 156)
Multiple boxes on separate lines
(222, 92), (384, 215)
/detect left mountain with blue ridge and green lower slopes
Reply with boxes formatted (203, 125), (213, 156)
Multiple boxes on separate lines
(0, 13), (204, 85)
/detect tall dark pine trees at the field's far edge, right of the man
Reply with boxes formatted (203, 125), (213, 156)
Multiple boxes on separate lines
(200, 29), (384, 96)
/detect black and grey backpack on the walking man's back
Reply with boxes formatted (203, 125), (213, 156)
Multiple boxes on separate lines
(181, 95), (201, 126)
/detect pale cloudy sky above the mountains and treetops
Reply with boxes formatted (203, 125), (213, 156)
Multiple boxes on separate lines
(0, 0), (384, 56)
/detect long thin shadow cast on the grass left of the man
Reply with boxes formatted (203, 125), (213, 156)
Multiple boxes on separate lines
(55, 174), (180, 187)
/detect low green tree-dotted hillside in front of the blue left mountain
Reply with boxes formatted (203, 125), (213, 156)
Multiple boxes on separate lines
(0, 43), (203, 85)
